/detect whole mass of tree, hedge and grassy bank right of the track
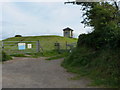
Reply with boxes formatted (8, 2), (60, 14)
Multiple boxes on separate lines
(62, 2), (120, 87)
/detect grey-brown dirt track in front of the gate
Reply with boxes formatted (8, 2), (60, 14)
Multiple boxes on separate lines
(2, 58), (94, 88)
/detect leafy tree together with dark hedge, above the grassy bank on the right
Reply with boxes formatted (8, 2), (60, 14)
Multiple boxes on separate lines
(65, 1), (120, 49)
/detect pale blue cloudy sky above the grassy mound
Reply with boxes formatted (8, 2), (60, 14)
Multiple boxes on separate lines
(0, 1), (91, 39)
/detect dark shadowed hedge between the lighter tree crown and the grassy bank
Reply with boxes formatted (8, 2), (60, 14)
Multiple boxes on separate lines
(78, 29), (120, 50)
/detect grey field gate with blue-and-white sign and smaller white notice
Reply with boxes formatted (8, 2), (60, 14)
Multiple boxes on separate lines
(2, 41), (40, 55)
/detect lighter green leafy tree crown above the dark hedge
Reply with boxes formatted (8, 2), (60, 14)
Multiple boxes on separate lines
(82, 2), (120, 31)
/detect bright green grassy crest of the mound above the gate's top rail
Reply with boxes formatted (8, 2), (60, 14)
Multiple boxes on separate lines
(3, 35), (77, 42)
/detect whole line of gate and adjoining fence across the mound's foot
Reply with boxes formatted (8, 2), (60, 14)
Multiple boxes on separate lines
(2, 41), (76, 55)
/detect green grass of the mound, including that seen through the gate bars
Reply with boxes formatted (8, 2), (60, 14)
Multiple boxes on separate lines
(3, 36), (77, 54)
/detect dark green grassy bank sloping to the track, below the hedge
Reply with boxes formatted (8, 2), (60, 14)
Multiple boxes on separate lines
(62, 46), (120, 87)
